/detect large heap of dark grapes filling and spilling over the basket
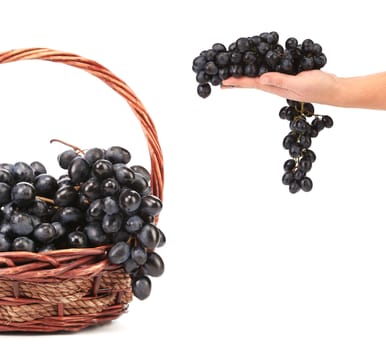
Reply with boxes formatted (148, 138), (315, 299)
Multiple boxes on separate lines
(0, 146), (165, 300)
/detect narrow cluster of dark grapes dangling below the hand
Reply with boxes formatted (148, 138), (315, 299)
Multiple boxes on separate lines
(279, 100), (334, 193)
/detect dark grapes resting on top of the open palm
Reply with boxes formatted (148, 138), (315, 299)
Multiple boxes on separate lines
(192, 32), (327, 98)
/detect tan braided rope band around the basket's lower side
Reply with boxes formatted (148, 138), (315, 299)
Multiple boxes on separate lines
(0, 270), (133, 330)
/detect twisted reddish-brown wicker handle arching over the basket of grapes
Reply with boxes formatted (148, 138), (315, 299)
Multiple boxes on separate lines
(0, 48), (164, 200)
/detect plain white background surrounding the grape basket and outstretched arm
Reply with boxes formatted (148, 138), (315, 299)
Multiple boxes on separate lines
(0, 0), (386, 350)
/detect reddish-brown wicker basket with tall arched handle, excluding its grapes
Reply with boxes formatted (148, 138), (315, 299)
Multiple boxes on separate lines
(0, 48), (163, 332)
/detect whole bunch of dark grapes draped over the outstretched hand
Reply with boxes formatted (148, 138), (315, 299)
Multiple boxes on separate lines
(192, 32), (333, 193)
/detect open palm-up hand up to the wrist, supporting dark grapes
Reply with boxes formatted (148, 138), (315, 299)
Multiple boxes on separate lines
(222, 70), (339, 105)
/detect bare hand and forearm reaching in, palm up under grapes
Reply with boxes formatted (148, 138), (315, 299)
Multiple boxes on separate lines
(222, 70), (386, 110)
